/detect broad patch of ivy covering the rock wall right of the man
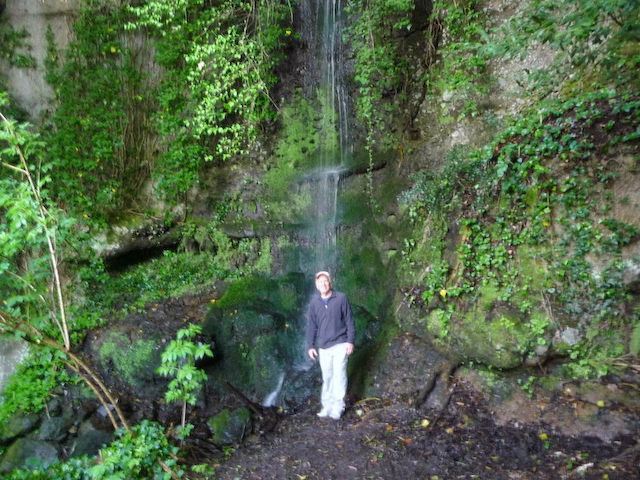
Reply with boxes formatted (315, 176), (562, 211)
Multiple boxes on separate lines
(403, 90), (640, 375)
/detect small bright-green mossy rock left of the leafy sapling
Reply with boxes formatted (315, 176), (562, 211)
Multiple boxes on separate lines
(98, 332), (162, 388)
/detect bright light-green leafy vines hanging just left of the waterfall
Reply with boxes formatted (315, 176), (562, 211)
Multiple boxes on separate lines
(127, 0), (292, 198)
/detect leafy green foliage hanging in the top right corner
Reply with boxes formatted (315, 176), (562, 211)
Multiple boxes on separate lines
(488, 0), (640, 94)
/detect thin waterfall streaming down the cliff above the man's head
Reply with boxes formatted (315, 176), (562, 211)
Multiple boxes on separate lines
(301, 0), (353, 272)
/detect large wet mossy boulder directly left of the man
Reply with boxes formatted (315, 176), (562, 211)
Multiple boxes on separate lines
(202, 274), (310, 399)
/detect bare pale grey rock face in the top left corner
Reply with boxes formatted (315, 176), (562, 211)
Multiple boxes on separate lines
(0, 0), (78, 120)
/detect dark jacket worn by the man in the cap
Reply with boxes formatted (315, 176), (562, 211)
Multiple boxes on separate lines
(307, 291), (356, 349)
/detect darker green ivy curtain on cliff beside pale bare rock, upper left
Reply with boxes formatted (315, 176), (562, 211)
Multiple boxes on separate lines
(45, 0), (153, 221)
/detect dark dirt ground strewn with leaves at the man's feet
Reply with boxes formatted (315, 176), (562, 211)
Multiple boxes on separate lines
(216, 382), (640, 480)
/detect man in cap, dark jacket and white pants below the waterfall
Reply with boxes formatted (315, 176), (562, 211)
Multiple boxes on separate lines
(307, 271), (355, 420)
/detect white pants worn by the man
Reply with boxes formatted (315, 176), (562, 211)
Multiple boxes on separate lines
(319, 343), (348, 415)
